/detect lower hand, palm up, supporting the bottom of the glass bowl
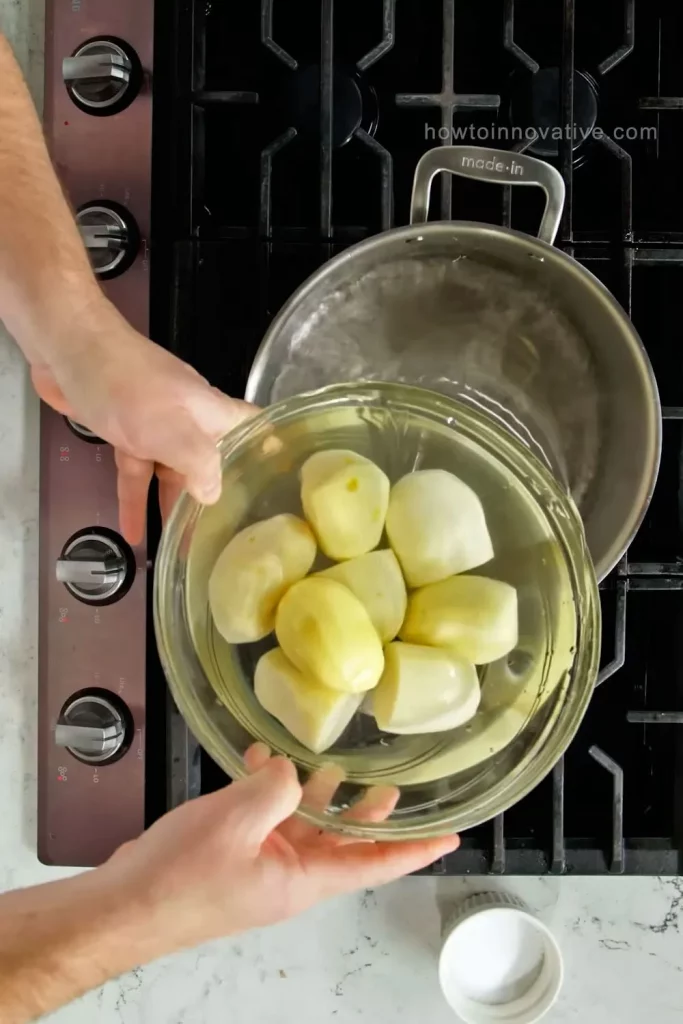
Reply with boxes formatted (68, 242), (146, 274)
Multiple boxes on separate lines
(99, 743), (459, 955)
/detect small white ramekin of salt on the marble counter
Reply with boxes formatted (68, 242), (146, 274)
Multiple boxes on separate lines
(438, 893), (563, 1024)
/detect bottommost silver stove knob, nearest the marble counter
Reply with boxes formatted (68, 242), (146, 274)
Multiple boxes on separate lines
(54, 690), (132, 764)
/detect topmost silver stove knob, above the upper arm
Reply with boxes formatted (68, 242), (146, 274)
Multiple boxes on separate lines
(61, 37), (142, 116)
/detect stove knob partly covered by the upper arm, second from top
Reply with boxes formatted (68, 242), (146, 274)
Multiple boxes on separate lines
(76, 200), (140, 281)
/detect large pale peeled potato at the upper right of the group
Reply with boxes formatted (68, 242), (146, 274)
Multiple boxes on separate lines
(386, 469), (494, 587)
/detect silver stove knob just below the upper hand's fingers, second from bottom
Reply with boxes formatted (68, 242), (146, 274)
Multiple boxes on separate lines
(56, 526), (135, 604)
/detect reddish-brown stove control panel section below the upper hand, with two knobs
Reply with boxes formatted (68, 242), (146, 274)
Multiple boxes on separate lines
(38, 411), (148, 866)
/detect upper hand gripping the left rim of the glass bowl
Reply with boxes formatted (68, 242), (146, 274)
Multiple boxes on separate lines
(31, 295), (255, 545)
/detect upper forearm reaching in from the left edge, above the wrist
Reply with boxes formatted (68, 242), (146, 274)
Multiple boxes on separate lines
(0, 35), (99, 361)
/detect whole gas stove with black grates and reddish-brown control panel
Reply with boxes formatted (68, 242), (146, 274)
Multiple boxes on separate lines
(39, 0), (683, 874)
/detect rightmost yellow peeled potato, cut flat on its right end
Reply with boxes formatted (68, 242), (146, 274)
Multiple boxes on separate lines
(400, 575), (518, 665)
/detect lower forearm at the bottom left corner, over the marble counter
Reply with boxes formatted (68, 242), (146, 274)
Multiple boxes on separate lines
(0, 869), (168, 1024)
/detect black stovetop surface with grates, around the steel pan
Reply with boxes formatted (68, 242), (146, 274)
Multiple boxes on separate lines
(148, 0), (683, 874)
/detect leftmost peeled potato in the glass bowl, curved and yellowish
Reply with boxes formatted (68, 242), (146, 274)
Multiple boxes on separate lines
(209, 514), (316, 643)
